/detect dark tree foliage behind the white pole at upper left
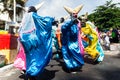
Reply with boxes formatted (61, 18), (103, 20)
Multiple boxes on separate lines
(0, 0), (27, 19)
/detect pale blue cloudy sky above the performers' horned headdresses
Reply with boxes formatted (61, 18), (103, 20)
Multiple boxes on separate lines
(26, 0), (120, 18)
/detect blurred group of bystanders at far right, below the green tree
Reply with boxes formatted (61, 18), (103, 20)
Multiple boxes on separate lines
(100, 28), (120, 50)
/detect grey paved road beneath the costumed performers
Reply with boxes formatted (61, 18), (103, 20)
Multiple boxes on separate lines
(0, 53), (120, 80)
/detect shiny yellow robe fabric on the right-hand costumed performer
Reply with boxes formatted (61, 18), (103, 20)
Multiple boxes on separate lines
(82, 22), (99, 60)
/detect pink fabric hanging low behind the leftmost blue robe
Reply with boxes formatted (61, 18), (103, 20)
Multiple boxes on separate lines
(13, 42), (26, 70)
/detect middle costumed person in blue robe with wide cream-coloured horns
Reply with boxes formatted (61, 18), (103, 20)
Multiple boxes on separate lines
(61, 5), (84, 72)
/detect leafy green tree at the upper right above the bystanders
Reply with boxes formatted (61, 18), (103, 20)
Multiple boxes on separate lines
(88, 0), (120, 30)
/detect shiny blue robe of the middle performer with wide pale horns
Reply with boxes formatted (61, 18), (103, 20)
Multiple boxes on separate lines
(62, 20), (84, 69)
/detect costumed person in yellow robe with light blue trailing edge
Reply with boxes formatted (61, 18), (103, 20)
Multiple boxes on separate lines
(80, 13), (104, 62)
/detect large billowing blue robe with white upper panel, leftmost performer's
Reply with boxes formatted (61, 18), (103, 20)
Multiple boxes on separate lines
(20, 12), (54, 76)
